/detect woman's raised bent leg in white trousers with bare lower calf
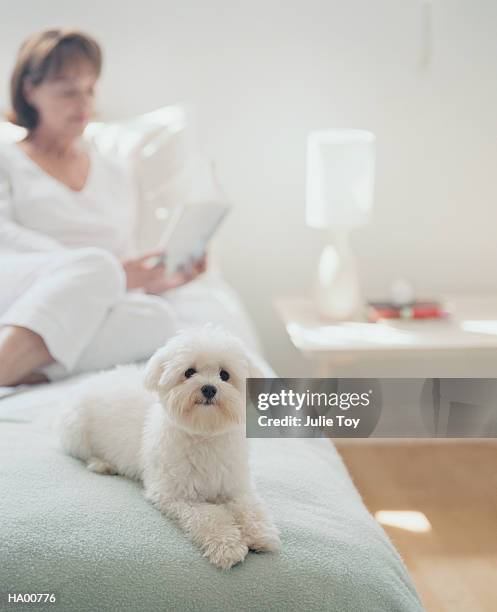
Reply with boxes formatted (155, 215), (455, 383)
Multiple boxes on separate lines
(0, 248), (125, 385)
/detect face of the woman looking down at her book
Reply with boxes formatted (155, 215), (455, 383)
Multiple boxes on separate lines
(25, 61), (98, 138)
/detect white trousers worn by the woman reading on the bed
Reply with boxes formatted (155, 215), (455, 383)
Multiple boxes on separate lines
(0, 248), (259, 380)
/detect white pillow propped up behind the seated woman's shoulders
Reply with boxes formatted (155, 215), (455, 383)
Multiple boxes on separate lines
(0, 106), (195, 249)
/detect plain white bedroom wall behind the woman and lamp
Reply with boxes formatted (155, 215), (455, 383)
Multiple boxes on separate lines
(0, 0), (497, 375)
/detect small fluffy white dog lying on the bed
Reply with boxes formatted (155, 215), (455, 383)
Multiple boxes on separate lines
(60, 326), (280, 569)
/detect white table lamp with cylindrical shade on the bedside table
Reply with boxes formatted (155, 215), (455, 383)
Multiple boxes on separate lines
(306, 130), (376, 320)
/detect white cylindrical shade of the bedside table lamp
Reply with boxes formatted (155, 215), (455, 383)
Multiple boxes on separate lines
(306, 130), (376, 228)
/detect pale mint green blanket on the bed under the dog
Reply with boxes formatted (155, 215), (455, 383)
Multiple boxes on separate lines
(0, 382), (422, 612)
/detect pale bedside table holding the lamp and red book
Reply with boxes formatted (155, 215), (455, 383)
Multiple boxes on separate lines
(274, 296), (497, 378)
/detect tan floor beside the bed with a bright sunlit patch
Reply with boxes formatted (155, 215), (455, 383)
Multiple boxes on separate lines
(335, 440), (497, 612)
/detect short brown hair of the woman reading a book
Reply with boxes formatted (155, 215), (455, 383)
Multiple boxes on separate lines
(7, 30), (102, 130)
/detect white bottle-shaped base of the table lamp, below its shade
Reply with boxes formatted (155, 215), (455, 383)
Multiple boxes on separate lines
(315, 232), (362, 321)
